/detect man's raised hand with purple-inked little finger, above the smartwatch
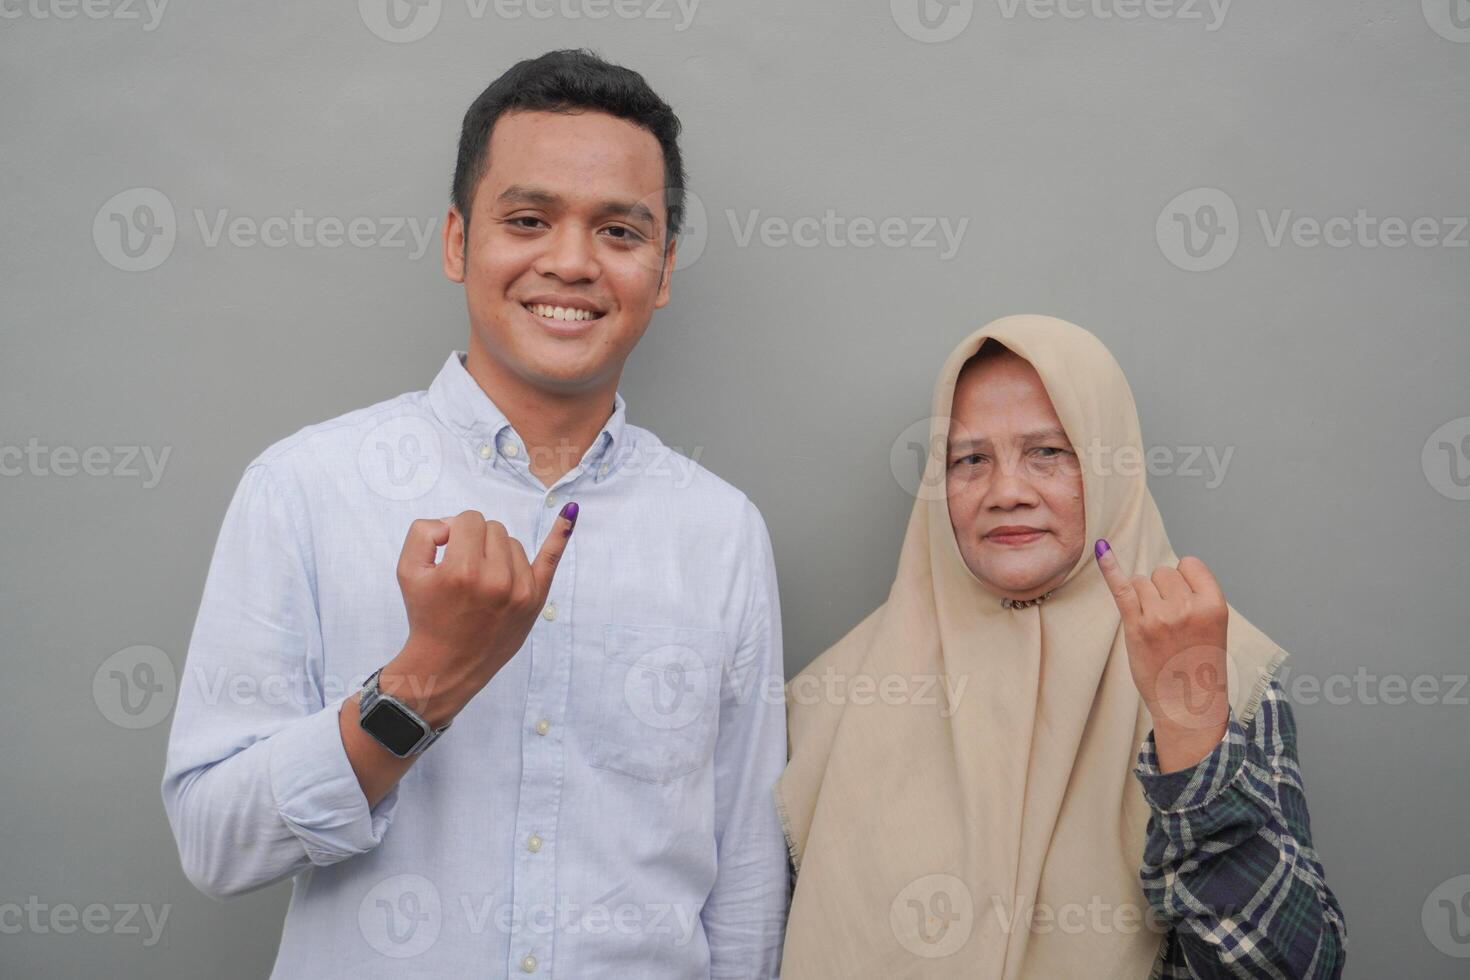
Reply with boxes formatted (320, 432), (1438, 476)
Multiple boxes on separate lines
(379, 504), (578, 727)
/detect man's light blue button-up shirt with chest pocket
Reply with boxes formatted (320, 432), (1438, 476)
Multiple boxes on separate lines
(163, 351), (789, 980)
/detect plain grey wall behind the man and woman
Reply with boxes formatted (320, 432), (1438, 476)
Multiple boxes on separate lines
(0, 0), (1470, 980)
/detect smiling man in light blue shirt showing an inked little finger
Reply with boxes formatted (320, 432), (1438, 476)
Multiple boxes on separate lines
(163, 51), (788, 980)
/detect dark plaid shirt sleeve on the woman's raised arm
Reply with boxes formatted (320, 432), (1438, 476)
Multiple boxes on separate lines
(1133, 680), (1347, 980)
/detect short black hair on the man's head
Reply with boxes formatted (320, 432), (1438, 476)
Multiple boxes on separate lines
(451, 48), (685, 247)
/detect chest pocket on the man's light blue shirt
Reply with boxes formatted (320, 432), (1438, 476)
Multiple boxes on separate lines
(588, 626), (725, 783)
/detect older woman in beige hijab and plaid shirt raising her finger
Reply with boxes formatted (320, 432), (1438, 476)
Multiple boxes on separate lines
(776, 316), (1344, 980)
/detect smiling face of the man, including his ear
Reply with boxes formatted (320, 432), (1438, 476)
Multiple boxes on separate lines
(444, 112), (673, 394)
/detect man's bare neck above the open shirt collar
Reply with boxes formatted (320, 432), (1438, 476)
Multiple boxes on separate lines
(465, 338), (617, 486)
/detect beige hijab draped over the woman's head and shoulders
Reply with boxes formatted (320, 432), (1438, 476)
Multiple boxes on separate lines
(776, 316), (1286, 980)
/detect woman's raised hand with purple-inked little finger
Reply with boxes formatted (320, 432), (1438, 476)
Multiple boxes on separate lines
(1097, 539), (1230, 773)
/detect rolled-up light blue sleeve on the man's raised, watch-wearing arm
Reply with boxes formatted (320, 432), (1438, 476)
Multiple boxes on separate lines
(162, 460), (398, 899)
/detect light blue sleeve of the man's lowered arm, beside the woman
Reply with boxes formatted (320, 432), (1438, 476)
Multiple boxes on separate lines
(701, 501), (791, 980)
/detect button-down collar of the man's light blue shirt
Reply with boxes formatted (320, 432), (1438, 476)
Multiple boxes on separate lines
(429, 351), (628, 482)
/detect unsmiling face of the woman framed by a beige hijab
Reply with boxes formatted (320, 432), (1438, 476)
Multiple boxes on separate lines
(945, 351), (1086, 599)
